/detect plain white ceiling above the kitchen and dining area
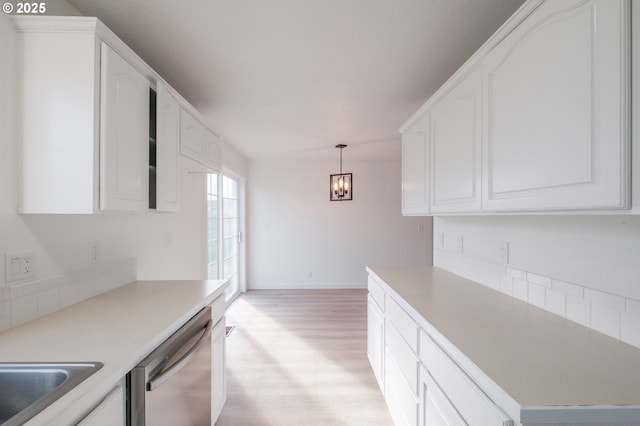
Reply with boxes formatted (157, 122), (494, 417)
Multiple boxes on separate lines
(69, 0), (523, 159)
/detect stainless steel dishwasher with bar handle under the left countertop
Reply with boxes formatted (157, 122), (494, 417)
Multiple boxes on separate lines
(127, 306), (213, 426)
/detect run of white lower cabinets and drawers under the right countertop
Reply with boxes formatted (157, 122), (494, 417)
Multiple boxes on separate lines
(367, 276), (514, 426)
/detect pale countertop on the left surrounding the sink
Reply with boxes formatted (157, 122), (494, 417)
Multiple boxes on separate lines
(0, 280), (225, 426)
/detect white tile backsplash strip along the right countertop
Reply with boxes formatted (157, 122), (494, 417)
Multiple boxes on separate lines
(433, 248), (640, 348)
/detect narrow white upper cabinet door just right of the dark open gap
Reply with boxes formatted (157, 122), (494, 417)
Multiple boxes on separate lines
(156, 82), (180, 212)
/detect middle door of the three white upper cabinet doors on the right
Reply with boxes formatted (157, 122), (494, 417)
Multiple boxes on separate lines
(430, 69), (482, 213)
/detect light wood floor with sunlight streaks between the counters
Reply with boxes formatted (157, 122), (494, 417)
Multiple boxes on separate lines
(216, 290), (393, 426)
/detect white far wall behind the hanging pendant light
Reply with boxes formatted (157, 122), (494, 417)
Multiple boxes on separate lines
(248, 155), (431, 289)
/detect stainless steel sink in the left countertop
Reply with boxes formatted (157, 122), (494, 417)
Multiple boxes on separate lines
(0, 362), (103, 426)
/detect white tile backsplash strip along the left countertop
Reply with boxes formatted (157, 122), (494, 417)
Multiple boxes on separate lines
(0, 259), (137, 331)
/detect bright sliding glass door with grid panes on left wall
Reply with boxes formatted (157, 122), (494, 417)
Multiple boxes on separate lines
(207, 174), (241, 300)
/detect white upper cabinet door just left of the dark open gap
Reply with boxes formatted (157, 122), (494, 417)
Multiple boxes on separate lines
(100, 43), (149, 211)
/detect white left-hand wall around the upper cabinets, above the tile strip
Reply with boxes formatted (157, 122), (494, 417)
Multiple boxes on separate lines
(0, 10), (246, 330)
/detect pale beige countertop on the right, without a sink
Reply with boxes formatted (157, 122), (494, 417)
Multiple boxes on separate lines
(367, 267), (640, 407)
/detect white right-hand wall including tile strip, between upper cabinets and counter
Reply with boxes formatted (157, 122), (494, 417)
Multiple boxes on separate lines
(434, 215), (640, 347)
